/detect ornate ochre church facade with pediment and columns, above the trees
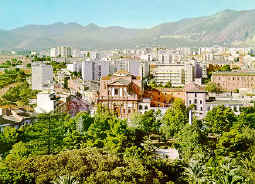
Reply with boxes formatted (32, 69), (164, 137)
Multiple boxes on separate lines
(98, 72), (142, 118)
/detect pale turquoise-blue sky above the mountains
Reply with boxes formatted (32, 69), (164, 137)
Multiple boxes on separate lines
(0, 0), (255, 30)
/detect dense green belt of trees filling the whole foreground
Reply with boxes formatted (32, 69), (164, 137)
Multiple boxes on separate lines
(0, 101), (255, 184)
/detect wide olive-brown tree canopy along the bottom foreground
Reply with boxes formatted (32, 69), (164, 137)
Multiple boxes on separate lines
(0, 148), (178, 183)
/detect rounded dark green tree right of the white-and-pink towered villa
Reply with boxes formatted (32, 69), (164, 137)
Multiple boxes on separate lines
(204, 105), (237, 134)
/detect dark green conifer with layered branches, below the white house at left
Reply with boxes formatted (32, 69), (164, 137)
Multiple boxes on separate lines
(16, 113), (68, 155)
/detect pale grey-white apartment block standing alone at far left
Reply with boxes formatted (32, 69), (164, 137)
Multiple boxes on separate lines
(32, 63), (53, 90)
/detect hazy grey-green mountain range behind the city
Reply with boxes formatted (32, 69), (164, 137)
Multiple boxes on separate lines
(0, 10), (255, 49)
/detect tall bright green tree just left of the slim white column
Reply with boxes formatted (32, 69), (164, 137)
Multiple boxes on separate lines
(161, 99), (188, 138)
